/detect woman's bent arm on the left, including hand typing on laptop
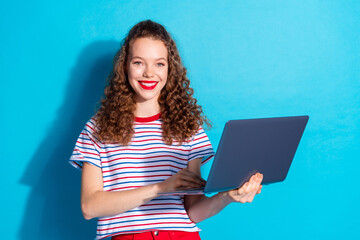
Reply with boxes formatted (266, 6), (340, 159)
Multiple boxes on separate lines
(81, 162), (204, 219)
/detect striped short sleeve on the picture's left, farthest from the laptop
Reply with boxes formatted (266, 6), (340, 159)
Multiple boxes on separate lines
(69, 118), (101, 170)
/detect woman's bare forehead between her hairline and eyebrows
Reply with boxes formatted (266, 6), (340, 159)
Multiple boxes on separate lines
(129, 38), (168, 59)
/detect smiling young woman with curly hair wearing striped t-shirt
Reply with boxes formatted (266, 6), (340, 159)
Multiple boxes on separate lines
(70, 20), (262, 239)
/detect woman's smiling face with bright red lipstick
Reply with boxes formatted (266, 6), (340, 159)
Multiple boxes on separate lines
(127, 38), (168, 102)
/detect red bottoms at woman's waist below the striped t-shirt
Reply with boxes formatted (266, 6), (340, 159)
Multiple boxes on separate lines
(111, 230), (201, 240)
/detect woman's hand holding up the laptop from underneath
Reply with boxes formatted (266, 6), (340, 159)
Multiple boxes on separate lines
(226, 173), (263, 203)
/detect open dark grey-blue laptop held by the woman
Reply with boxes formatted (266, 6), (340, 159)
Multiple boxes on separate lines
(160, 116), (309, 195)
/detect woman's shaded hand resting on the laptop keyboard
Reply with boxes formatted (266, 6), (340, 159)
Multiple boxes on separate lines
(159, 168), (206, 193)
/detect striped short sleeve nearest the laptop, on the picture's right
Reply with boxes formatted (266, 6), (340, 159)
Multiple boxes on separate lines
(188, 127), (215, 165)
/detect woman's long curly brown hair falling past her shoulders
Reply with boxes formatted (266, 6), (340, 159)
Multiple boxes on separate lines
(95, 20), (211, 145)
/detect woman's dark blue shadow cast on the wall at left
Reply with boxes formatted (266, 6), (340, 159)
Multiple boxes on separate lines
(18, 41), (119, 240)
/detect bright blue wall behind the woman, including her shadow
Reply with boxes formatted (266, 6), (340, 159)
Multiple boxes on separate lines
(0, 0), (360, 239)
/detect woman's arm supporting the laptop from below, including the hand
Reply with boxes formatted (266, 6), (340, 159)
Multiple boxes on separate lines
(185, 158), (263, 222)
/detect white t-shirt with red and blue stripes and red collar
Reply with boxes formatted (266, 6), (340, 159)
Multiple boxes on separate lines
(70, 114), (214, 239)
